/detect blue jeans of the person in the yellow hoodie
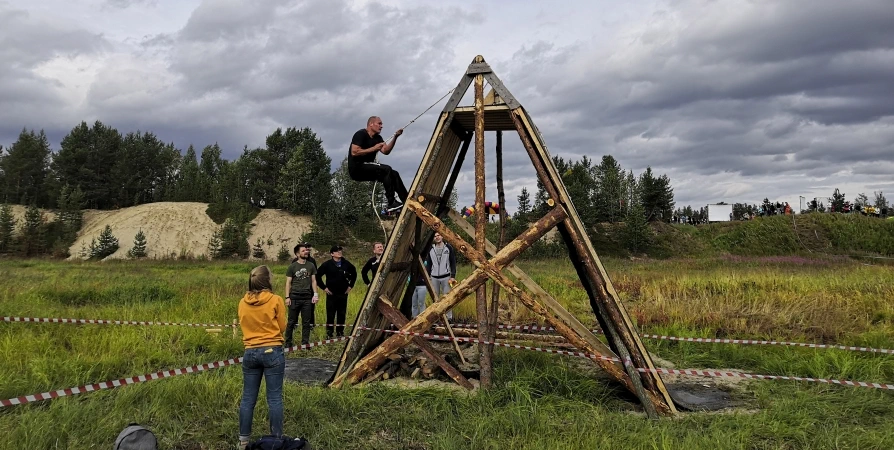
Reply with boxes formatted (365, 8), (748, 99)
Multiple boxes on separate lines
(239, 346), (286, 438)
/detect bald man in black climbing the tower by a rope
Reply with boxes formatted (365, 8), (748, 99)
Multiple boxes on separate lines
(348, 116), (407, 212)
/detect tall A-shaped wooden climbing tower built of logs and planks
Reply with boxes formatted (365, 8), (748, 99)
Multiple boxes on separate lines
(332, 56), (675, 417)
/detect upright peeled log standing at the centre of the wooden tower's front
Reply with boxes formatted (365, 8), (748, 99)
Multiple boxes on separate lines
(475, 70), (492, 389)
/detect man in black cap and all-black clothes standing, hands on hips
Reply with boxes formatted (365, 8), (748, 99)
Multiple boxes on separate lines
(317, 245), (357, 339)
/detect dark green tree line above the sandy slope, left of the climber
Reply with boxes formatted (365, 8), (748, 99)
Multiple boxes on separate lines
(0, 121), (378, 255)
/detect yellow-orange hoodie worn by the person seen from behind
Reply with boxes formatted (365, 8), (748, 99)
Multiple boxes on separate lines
(239, 290), (286, 348)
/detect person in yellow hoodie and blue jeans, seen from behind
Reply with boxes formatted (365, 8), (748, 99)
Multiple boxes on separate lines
(239, 266), (286, 448)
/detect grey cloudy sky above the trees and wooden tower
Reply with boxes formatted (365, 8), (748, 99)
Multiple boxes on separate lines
(0, 0), (894, 210)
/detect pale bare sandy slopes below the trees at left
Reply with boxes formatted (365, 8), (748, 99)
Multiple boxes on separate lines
(67, 202), (310, 259)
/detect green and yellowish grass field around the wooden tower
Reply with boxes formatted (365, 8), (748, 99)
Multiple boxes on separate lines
(0, 256), (894, 449)
